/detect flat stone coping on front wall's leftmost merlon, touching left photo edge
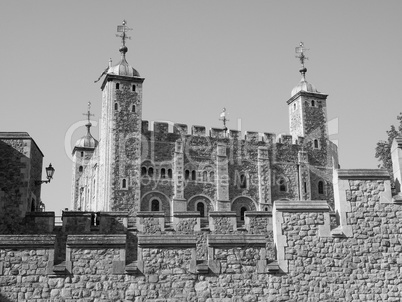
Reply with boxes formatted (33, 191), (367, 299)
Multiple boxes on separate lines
(0, 235), (56, 248)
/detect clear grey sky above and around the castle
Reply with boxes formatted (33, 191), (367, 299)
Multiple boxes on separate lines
(0, 0), (402, 215)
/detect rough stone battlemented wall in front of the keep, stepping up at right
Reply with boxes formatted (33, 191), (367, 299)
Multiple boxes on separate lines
(0, 170), (402, 301)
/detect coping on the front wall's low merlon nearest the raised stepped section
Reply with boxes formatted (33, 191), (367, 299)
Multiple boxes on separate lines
(207, 234), (267, 247)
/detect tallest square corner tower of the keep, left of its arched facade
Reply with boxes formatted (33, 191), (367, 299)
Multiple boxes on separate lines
(98, 21), (144, 214)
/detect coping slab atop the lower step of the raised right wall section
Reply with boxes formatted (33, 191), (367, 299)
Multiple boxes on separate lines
(276, 200), (330, 213)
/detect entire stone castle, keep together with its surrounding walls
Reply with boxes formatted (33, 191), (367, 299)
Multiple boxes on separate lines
(0, 24), (402, 302)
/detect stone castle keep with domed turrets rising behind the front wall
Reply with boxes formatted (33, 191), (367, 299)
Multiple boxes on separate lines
(71, 32), (338, 223)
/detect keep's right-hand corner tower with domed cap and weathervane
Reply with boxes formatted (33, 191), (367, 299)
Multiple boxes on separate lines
(287, 43), (338, 203)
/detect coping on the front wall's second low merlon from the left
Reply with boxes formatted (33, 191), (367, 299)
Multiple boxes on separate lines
(67, 234), (127, 247)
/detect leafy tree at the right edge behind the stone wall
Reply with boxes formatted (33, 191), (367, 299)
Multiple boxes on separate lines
(375, 112), (402, 182)
